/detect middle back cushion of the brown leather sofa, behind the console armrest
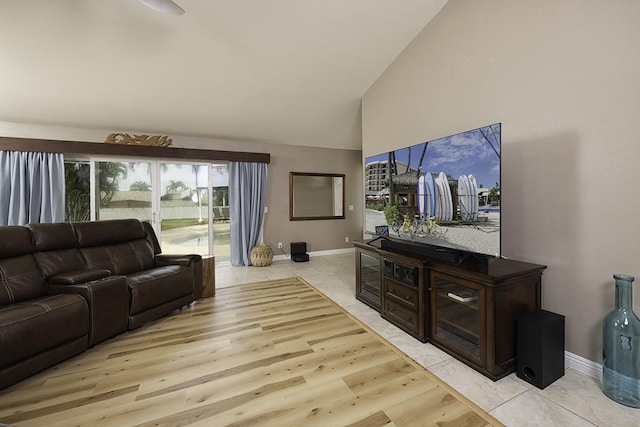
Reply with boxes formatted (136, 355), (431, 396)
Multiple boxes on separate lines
(27, 222), (85, 279)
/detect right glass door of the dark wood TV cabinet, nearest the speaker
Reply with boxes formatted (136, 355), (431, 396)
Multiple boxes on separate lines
(431, 272), (485, 363)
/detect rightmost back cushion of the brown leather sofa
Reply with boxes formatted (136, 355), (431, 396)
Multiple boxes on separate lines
(73, 219), (154, 274)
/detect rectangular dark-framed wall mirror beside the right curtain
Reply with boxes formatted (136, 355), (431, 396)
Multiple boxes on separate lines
(289, 172), (344, 221)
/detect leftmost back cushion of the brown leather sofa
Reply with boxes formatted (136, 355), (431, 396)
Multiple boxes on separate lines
(0, 226), (47, 307)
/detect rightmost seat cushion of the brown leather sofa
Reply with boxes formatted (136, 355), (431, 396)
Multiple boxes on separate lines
(126, 265), (194, 314)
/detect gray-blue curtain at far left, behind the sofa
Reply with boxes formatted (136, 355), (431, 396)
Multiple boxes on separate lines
(0, 151), (64, 225)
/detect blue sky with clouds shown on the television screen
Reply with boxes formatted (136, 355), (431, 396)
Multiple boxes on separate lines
(365, 123), (500, 188)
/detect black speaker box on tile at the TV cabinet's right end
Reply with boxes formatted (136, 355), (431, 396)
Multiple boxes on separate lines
(516, 310), (564, 389)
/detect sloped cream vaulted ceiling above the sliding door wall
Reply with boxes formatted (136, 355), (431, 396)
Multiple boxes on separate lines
(0, 0), (446, 149)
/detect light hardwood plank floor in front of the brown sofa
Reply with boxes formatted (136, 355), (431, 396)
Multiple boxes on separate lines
(0, 279), (501, 426)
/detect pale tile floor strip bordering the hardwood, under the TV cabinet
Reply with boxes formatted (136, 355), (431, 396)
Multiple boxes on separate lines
(216, 253), (640, 427)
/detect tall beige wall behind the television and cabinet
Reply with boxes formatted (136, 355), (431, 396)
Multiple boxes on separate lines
(363, 0), (640, 362)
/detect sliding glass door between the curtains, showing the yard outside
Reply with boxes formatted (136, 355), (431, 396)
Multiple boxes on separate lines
(65, 159), (230, 261)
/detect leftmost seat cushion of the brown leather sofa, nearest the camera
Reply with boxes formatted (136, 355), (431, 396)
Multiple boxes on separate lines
(0, 294), (89, 369)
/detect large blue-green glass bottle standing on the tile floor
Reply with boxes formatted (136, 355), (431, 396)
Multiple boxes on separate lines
(602, 274), (640, 408)
